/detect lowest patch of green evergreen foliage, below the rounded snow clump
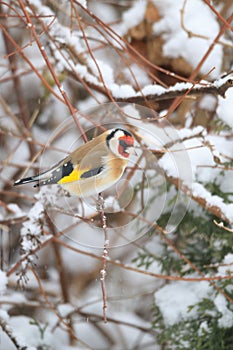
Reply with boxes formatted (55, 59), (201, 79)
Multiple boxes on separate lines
(152, 299), (233, 350)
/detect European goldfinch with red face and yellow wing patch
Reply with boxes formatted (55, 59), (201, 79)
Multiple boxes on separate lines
(14, 128), (135, 197)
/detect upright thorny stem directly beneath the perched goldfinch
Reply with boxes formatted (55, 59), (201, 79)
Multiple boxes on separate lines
(97, 193), (109, 323)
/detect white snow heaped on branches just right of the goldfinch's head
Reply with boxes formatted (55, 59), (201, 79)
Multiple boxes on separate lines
(155, 126), (233, 222)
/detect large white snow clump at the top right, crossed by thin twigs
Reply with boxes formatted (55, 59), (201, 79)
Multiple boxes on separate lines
(153, 0), (223, 78)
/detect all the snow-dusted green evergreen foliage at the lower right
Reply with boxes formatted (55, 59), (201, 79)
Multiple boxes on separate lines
(134, 190), (233, 350)
